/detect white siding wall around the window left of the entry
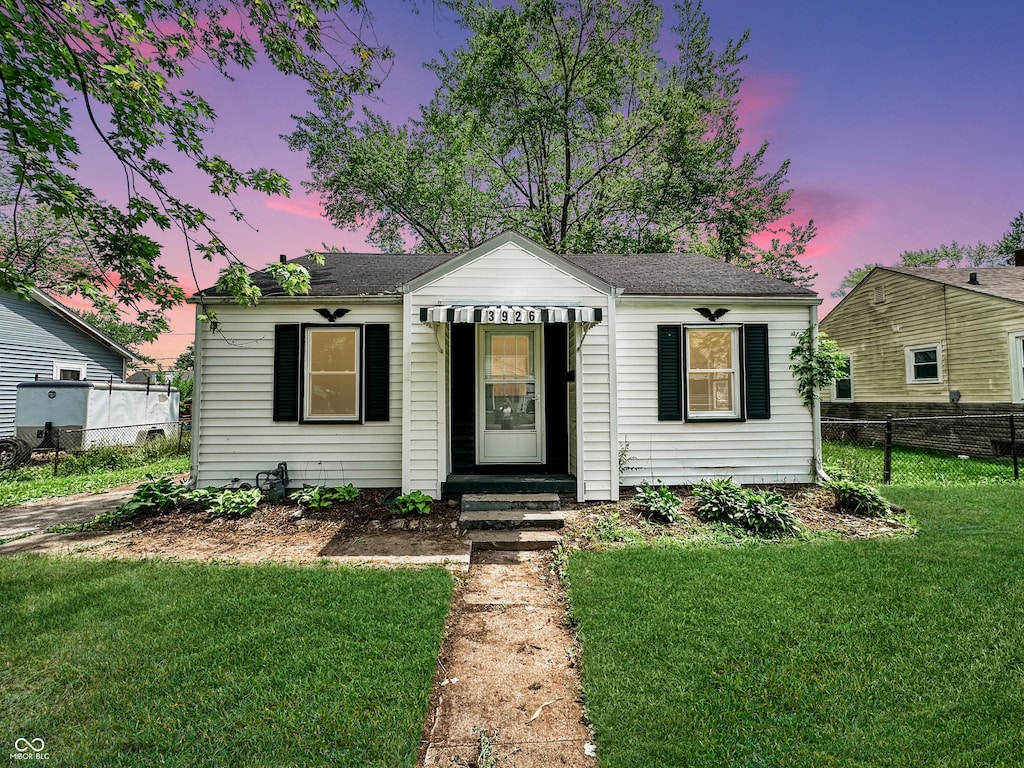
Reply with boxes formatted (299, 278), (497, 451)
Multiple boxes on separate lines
(193, 299), (403, 487)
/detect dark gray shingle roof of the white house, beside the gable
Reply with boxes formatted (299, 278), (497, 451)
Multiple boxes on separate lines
(214, 253), (816, 298)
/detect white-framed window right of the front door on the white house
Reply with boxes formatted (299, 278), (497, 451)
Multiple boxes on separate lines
(686, 327), (741, 419)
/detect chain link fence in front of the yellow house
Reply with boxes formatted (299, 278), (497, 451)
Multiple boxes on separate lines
(821, 414), (1024, 484)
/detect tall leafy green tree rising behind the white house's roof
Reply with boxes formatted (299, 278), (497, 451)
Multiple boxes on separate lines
(289, 0), (815, 282)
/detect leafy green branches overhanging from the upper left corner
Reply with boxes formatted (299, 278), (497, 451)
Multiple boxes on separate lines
(0, 0), (390, 313)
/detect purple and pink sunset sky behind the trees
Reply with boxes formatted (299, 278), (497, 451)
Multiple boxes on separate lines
(75, 0), (1024, 367)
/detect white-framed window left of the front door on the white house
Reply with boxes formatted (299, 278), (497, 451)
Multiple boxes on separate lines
(302, 326), (362, 421)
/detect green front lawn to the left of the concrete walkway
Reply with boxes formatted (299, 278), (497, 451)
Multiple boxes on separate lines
(0, 557), (452, 768)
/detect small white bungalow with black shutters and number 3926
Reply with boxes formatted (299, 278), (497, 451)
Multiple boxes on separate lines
(191, 233), (820, 500)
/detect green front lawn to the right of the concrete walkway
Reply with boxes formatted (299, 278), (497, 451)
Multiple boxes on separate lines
(568, 486), (1024, 768)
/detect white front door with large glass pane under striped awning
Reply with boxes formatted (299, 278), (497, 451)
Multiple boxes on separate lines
(476, 326), (545, 464)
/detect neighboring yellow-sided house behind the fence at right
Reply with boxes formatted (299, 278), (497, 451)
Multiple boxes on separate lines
(821, 260), (1024, 419)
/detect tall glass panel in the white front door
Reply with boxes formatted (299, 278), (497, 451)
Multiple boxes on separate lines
(483, 331), (537, 430)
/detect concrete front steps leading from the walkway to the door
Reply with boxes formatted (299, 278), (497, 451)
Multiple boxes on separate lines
(459, 494), (565, 551)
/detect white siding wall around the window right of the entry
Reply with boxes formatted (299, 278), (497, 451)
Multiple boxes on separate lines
(616, 297), (814, 485)
